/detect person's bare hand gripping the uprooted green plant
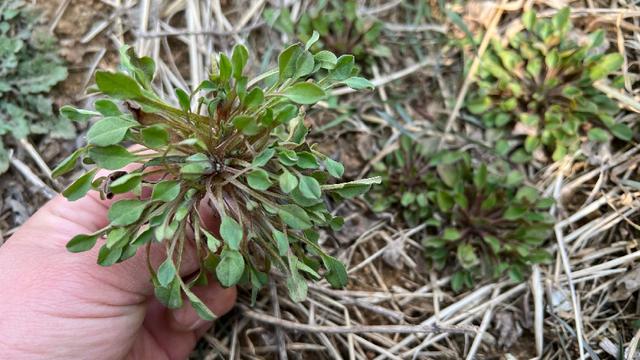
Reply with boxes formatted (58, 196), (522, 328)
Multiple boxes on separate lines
(0, 184), (236, 360)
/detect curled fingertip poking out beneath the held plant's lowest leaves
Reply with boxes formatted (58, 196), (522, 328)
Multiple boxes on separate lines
(168, 282), (236, 331)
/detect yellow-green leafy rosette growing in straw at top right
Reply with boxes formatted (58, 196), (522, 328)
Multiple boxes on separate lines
(466, 8), (633, 162)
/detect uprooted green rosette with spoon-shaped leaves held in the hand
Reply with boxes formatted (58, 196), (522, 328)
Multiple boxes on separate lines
(54, 39), (379, 318)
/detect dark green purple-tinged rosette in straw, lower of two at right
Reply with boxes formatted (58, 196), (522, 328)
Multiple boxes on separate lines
(368, 137), (553, 291)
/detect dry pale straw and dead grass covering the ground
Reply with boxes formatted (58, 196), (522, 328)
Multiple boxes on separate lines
(0, 0), (640, 360)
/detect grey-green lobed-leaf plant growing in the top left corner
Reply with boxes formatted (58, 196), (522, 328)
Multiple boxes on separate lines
(0, 0), (70, 173)
